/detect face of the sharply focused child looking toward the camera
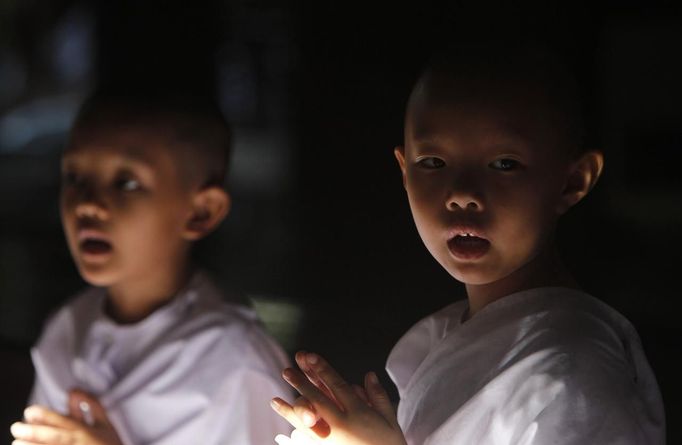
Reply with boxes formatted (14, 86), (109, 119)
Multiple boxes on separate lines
(396, 80), (570, 284)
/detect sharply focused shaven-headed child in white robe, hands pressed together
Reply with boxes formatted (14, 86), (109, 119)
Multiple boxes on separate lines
(272, 48), (665, 445)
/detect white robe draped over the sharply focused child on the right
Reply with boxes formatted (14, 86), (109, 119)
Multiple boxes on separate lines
(387, 288), (665, 445)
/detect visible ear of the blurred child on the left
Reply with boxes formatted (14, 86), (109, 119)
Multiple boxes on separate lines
(183, 186), (230, 241)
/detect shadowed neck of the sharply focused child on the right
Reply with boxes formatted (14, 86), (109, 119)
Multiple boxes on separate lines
(466, 247), (579, 318)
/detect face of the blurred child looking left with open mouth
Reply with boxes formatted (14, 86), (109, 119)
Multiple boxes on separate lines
(61, 123), (192, 286)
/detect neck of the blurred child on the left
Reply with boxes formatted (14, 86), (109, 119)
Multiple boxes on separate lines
(105, 261), (192, 324)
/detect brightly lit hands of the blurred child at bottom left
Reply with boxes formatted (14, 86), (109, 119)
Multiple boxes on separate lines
(11, 390), (122, 445)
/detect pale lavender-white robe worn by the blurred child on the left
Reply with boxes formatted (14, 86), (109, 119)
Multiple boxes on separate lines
(31, 273), (291, 445)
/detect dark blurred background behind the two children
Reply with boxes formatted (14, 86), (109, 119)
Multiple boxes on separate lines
(0, 0), (682, 443)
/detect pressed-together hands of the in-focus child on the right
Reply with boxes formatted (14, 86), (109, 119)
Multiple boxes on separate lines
(272, 353), (406, 445)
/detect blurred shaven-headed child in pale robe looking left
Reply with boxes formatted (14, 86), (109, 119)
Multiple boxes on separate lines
(11, 93), (288, 445)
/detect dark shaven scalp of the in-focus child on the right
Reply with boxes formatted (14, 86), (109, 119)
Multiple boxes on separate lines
(407, 45), (585, 155)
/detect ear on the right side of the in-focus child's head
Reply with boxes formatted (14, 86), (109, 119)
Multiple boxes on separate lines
(557, 150), (604, 215)
